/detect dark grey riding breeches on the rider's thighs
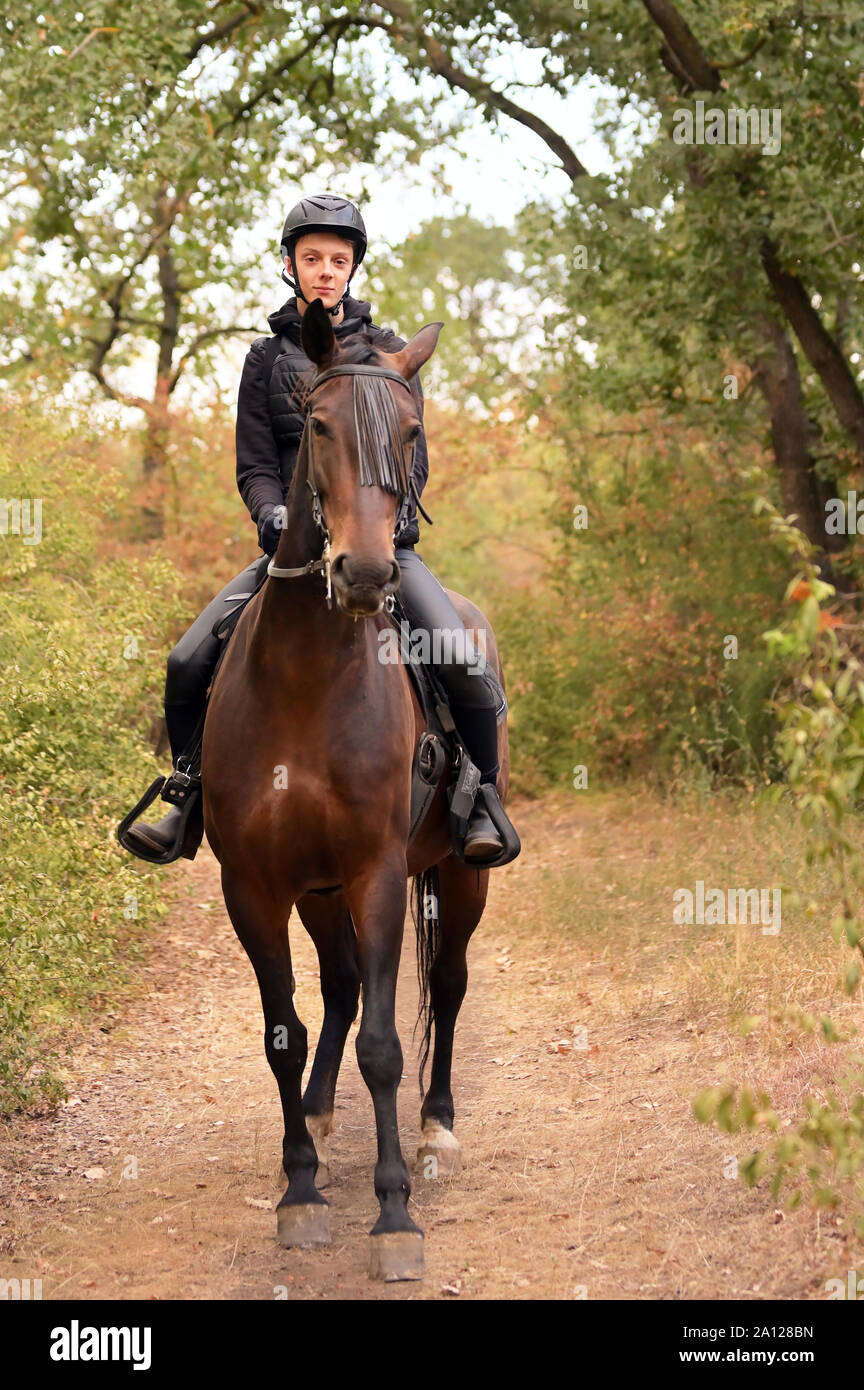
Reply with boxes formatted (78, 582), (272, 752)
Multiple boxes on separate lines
(165, 546), (500, 759)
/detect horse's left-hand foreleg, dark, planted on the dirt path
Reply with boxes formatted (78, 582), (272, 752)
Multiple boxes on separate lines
(222, 867), (331, 1245)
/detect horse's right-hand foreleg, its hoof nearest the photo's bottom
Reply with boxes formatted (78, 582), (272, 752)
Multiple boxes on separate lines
(347, 858), (424, 1282)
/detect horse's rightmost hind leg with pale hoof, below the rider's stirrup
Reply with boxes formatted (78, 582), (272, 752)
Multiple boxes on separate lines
(417, 858), (489, 1180)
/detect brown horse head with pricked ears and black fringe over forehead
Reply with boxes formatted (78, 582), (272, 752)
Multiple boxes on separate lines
(297, 300), (443, 617)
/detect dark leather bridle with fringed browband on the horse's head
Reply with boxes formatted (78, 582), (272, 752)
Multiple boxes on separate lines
(267, 363), (411, 609)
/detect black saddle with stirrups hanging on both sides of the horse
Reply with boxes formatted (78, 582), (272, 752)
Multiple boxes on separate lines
(117, 556), (521, 869)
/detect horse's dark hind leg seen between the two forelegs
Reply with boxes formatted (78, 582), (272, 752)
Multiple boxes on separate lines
(297, 894), (360, 1187)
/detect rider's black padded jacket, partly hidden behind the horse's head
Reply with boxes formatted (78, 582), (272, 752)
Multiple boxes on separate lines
(236, 295), (429, 545)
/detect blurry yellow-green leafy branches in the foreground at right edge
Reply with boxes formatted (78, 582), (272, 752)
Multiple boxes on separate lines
(693, 502), (864, 1237)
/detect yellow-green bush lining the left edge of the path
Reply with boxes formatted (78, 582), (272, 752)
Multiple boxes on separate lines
(0, 413), (182, 1109)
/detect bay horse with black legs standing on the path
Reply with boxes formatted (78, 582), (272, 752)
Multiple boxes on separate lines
(201, 300), (508, 1280)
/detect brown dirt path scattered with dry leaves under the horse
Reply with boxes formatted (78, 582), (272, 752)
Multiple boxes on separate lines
(0, 803), (854, 1300)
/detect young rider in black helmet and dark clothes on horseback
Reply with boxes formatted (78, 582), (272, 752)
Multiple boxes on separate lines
(122, 195), (513, 866)
